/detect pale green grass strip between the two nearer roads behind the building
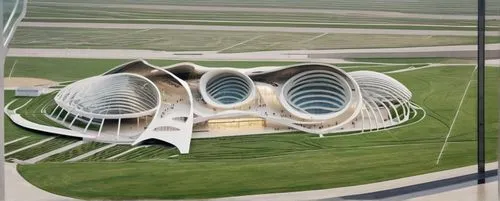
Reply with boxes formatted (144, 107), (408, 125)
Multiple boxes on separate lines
(11, 27), (488, 52)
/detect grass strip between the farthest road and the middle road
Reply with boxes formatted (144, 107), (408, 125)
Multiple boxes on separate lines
(24, 1), (500, 30)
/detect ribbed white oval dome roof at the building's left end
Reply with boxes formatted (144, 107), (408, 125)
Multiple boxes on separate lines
(54, 73), (159, 119)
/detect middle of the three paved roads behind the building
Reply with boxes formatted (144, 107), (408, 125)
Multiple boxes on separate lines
(19, 22), (500, 36)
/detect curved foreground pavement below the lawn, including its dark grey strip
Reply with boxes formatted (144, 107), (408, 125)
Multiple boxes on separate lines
(5, 162), (498, 201)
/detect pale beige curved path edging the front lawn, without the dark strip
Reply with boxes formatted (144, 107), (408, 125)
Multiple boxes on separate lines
(5, 162), (498, 201)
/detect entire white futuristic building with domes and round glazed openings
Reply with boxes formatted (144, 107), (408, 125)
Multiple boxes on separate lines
(10, 60), (416, 153)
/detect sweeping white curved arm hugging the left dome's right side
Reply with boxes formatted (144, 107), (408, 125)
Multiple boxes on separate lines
(103, 60), (193, 154)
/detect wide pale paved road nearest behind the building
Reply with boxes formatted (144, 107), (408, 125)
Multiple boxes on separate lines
(8, 44), (500, 61)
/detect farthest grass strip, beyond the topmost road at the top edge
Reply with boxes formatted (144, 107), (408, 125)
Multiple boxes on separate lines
(30, 0), (500, 15)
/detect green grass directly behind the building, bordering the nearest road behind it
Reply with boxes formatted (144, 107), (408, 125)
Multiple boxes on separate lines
(5, 57), (444, 81)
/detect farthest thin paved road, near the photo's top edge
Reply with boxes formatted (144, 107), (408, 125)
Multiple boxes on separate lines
(30, 2), (500, 20)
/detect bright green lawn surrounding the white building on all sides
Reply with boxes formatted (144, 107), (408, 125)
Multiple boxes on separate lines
(5, 58), (499, 199)
